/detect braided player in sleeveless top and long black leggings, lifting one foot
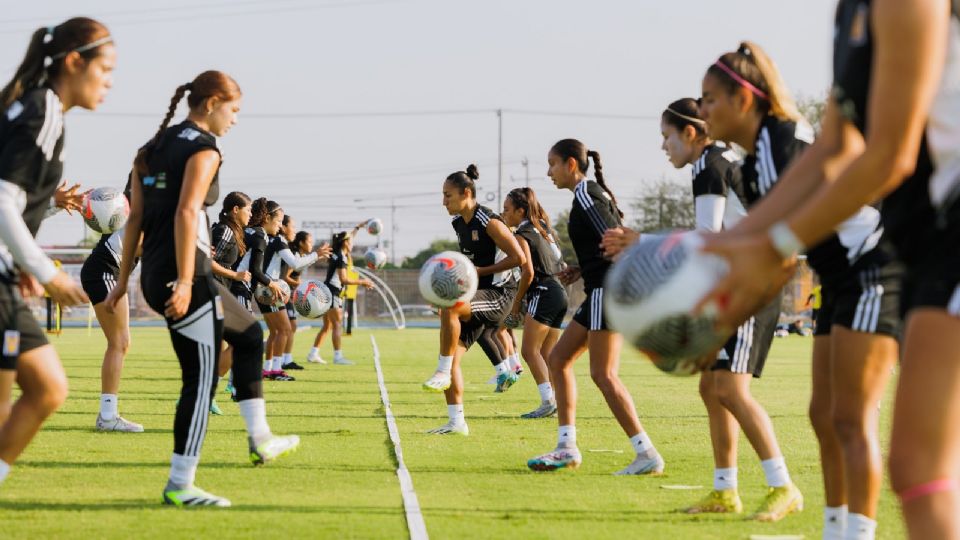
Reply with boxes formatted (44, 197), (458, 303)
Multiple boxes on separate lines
(106, 71), (300, 507)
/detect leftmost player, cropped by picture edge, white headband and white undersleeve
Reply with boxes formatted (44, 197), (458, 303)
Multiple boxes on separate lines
(0, 17), (116, 490)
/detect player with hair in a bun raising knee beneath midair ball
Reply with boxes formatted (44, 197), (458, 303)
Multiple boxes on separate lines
(423, 165), (526, 435)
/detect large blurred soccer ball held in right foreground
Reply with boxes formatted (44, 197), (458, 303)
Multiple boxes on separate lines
(603, 232), (729, 375)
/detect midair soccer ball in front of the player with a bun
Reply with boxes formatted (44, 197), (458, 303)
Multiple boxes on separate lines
(418, 251), (479, 307)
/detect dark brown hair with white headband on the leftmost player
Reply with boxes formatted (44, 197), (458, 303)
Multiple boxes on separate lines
(0, 17), (110, 109)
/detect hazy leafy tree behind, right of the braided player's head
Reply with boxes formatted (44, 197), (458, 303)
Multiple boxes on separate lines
(630, 177), (696, 232)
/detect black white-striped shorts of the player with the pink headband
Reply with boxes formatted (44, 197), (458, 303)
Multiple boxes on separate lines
(815, 250), (904, 337)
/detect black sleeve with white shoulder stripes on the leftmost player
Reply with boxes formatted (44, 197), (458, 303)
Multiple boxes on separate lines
(0, 92), (47, 192)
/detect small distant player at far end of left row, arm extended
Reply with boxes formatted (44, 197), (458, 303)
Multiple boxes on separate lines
(307, 224), (373, 366)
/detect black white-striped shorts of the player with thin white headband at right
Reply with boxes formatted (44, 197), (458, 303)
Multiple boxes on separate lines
(710, 294), (784, 378)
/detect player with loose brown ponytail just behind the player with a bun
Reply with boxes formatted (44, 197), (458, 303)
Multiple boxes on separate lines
(503, 188), (567, 418)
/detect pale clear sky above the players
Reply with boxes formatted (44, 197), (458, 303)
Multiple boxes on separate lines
(0, 0), (836, 257)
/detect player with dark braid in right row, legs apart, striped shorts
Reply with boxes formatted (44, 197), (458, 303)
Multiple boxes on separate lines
(527, 139), (664, 474)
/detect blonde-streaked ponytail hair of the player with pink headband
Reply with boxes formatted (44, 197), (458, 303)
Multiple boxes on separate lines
(707, 41), (802, 122)
